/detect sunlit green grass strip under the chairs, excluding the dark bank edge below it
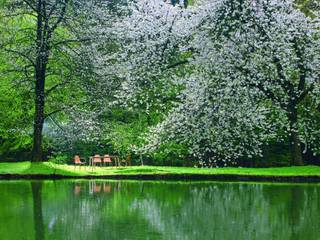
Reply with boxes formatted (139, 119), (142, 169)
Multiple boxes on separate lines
(0, 162), (320, 177)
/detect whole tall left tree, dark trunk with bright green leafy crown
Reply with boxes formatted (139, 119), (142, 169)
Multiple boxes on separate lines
(0, 0), (95, 161)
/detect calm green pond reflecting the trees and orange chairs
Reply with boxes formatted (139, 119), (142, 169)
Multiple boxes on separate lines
(0, 180), (320, 240)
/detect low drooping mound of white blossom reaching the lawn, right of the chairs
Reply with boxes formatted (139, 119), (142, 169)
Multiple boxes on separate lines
(140, 74), (275, 166)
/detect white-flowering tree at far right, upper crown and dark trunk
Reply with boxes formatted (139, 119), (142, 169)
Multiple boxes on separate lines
(195, 0), (320, 165)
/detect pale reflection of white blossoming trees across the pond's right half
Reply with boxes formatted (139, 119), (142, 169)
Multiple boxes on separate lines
(133, 184), (320, 240)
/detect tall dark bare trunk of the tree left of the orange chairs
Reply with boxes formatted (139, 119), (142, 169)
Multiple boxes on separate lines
(32, 0), (48, 162)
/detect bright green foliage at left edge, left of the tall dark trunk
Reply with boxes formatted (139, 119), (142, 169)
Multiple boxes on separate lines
(0, 43), (33, 161)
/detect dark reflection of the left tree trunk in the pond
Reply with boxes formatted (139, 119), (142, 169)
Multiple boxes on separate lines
(31, 182), (44, 240)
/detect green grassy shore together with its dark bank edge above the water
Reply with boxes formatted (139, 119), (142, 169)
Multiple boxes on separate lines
(0, 162), (320, 183)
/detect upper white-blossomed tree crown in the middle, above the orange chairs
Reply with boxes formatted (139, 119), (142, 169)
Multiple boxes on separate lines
(88, 0), (190, 158)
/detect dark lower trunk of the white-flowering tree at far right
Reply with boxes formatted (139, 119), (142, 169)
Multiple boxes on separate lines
(288, 103), (303, 166)
